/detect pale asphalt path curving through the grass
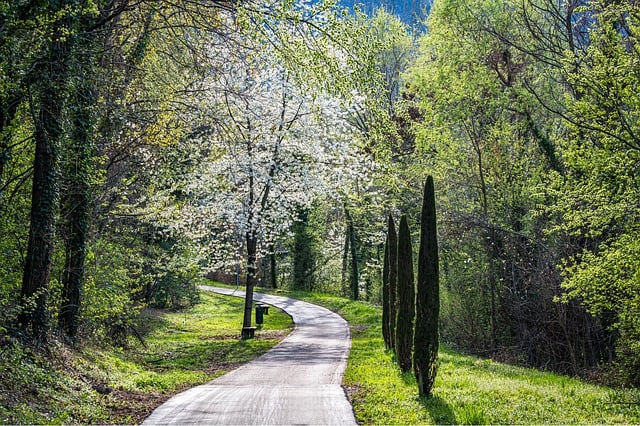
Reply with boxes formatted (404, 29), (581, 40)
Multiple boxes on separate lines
(143, 286), (357, 425)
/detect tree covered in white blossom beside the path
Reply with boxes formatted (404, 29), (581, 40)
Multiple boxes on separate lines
(148, 30), (364, 337)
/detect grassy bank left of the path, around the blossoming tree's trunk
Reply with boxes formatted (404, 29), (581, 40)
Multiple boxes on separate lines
(0, 292), (293, 424)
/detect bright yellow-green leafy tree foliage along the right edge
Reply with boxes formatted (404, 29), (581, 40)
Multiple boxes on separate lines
(550, 1), (640, 385)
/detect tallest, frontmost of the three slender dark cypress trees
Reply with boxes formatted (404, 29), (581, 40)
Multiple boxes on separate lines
(413, 176), (440, 396)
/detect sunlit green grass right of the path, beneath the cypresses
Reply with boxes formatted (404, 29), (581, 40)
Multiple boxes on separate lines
(274, 292), (640, 424)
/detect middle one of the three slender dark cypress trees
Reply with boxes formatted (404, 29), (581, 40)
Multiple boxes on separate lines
(396, 215), (415, 373)
